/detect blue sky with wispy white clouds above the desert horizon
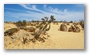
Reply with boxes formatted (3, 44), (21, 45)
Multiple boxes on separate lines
(4, 4), (84, 21)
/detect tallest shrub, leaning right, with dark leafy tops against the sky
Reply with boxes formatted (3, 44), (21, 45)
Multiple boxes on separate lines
(35, 15), (55, 39)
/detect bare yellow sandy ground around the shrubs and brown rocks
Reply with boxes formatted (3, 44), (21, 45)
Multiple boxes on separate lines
(4, 24), (84, 49)
